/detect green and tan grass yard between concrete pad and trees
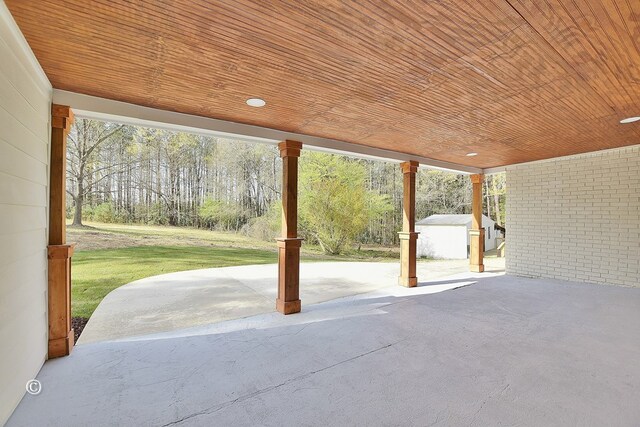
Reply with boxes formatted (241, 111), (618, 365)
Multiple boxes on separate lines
(67, 223), (398, 318)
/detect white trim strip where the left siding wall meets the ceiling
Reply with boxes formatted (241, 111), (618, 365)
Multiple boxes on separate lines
(0, 0), (52, 94)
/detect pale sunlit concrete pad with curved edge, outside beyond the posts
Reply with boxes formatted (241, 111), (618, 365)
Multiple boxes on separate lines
(78, 258), (504, 344)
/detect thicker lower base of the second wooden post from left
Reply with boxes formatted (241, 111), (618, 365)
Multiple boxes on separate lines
(276, 237), (303, 314)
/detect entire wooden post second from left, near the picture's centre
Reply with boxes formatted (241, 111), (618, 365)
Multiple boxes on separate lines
(276, 140), (302, 314)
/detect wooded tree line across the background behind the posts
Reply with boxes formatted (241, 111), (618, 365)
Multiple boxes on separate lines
(67, 119), (506, 253)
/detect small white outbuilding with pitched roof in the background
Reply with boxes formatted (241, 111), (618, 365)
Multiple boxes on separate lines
(416, 214), (502, 259)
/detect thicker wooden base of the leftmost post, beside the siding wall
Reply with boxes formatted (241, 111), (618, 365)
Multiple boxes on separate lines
(47, 245), (74, 359)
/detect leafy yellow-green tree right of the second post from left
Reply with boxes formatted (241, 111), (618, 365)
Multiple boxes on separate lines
(299, 152), (391, 254)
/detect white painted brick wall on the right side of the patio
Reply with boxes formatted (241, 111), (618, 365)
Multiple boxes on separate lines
(506, 145), (640, 287)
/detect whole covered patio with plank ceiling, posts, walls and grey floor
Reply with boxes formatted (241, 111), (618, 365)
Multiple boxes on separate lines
(0, 0), (640, 425)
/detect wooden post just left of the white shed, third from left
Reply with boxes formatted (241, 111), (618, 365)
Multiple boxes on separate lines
(398, 161), (419, 287)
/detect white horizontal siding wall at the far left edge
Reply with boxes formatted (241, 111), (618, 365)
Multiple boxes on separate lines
(0, 0), (52, 425)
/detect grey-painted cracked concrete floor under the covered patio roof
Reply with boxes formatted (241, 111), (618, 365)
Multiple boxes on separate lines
(8, 273), (640, 426)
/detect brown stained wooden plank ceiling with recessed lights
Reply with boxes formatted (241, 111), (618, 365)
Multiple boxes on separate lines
(5, 0), (640, 168)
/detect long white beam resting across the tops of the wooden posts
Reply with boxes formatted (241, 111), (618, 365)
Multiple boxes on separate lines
(53, 89), (482, 174)
